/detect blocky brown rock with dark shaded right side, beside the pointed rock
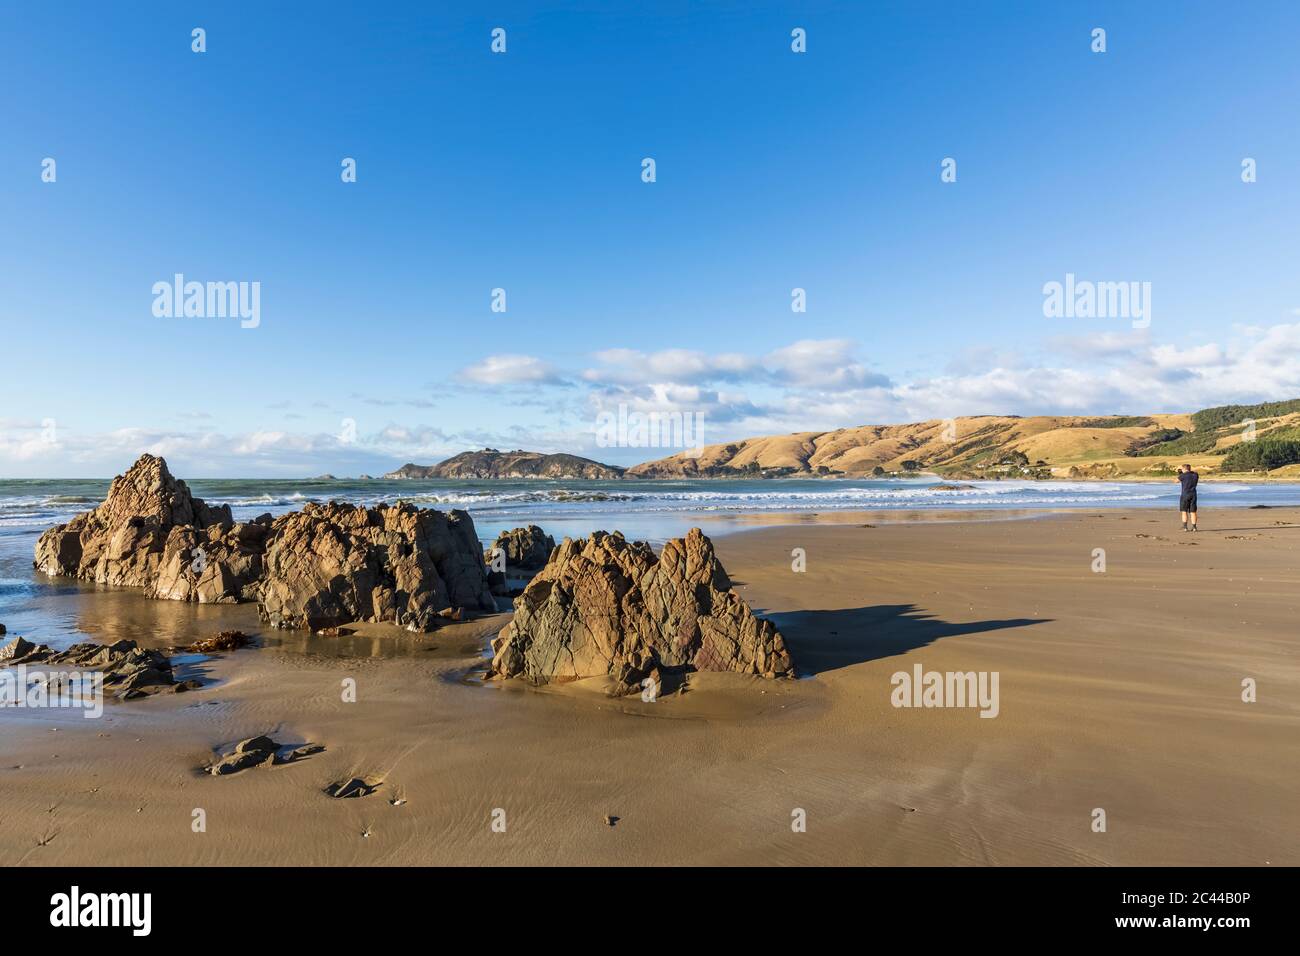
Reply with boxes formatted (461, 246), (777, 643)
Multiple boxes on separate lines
(259, 502), (497, 631)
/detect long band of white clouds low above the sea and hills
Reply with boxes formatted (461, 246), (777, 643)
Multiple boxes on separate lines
(10, 329), (1300, 476)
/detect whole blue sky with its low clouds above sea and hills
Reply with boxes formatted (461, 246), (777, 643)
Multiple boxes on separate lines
(0, 3), (1300, 477)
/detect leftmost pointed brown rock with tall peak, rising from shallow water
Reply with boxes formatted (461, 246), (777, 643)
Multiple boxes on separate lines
(34, 455), (263, 604)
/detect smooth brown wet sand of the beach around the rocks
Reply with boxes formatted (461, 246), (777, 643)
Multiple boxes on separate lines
(0, 509), (1300, 865)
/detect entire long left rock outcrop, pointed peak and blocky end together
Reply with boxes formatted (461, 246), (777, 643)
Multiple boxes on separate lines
(34, 455), (495, 631)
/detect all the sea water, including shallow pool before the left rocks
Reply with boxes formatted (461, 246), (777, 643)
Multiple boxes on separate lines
(0, 477), (1300, 645)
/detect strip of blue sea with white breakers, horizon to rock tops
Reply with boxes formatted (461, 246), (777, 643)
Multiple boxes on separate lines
(0, 477), (1300, 540)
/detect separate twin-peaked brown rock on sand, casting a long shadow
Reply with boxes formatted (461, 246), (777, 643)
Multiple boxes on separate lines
(490, 528), (794, 687)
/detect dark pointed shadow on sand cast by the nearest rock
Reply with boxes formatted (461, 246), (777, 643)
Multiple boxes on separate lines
(763, 604), (1050, 675)
